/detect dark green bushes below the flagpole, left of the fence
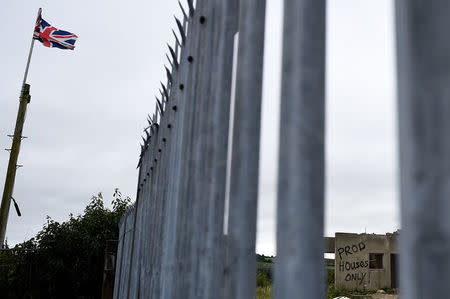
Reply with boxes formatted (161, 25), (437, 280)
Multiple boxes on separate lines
(0, 189), (131, 298)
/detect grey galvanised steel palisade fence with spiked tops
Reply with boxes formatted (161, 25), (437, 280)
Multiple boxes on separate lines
(114, 0), (450, 299)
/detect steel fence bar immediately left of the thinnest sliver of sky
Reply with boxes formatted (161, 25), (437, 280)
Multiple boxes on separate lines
(203, 0), (239, 298)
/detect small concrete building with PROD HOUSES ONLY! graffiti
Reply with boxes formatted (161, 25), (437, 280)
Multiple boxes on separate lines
(326, 233), (398, 290)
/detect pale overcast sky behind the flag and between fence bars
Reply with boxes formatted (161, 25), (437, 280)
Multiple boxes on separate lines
(0, 0), (400, 254)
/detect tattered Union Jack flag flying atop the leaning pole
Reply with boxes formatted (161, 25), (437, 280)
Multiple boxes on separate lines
(33, 13), (78, 50)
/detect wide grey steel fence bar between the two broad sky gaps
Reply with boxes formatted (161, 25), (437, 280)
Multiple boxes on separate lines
(275, 0), (326, 299)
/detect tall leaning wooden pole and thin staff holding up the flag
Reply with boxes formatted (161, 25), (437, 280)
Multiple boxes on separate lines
(0, 8), (42, 247)
